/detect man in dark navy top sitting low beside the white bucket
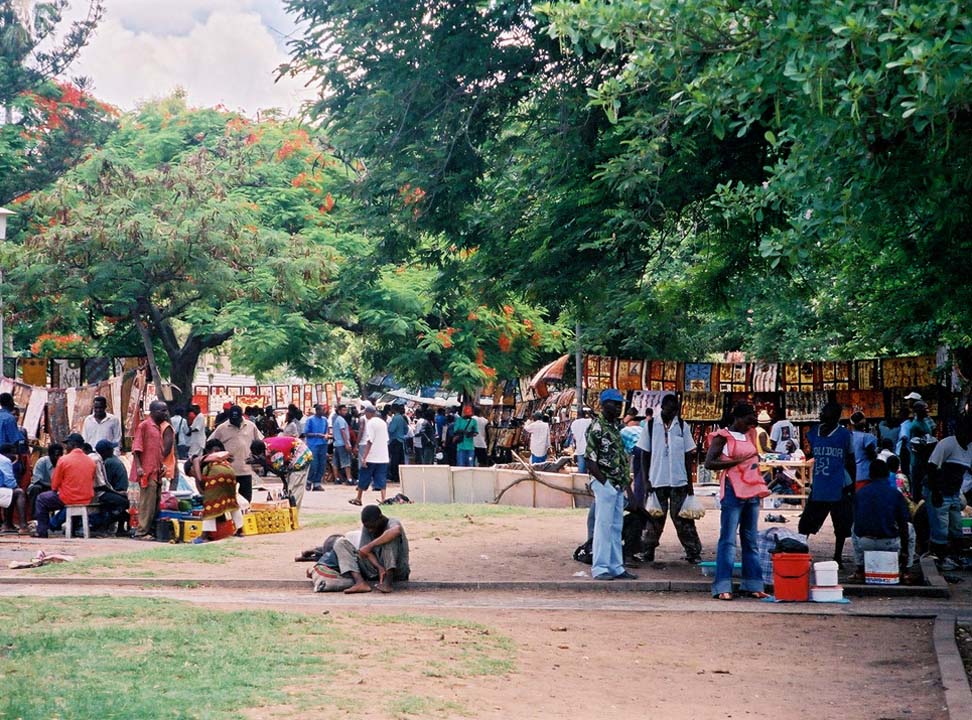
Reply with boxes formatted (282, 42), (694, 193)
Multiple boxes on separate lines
(851, 460), (915, 583)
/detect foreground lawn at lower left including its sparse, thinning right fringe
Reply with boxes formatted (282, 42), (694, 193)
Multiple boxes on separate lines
(0, 597), (515, 720)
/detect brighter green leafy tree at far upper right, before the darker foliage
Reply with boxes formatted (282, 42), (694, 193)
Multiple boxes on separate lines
(540, 0), (972, 357)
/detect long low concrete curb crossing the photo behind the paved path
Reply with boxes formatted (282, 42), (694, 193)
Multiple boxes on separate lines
(0, 563), (949, 599)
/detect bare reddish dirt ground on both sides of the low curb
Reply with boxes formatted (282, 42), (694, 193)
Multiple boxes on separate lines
(0, 478), (956, 720)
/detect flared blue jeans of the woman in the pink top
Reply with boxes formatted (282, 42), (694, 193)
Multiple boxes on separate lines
(712, 480), (763, 595)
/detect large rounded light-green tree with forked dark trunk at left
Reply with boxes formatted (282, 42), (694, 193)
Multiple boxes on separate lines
(10, 98), (360, 402)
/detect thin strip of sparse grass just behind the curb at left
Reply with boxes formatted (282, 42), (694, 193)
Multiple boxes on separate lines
(30, 540), (246, 577)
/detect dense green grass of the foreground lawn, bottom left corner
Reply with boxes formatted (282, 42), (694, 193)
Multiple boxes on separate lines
(0, 598), (347, 720)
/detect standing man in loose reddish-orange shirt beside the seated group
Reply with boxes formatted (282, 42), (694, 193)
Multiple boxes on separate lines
(128, 400), (175, 540)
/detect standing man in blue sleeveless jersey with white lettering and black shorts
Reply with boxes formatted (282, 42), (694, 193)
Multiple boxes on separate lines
(798, 403), (857, 567)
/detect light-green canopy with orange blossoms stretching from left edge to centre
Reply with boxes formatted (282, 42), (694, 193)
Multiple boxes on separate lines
(9, 96), (562, 390)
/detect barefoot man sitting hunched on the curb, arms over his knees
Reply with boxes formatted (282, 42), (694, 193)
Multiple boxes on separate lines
(334, 505), (410, 594)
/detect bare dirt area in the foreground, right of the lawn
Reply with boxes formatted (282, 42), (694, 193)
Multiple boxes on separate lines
(288, 609), (947, 720)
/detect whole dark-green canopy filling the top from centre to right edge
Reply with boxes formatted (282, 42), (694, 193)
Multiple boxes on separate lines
(283, 0), (972, 359)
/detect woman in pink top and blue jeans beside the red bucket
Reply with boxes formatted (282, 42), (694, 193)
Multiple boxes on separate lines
(705, 403), (769, 600)
